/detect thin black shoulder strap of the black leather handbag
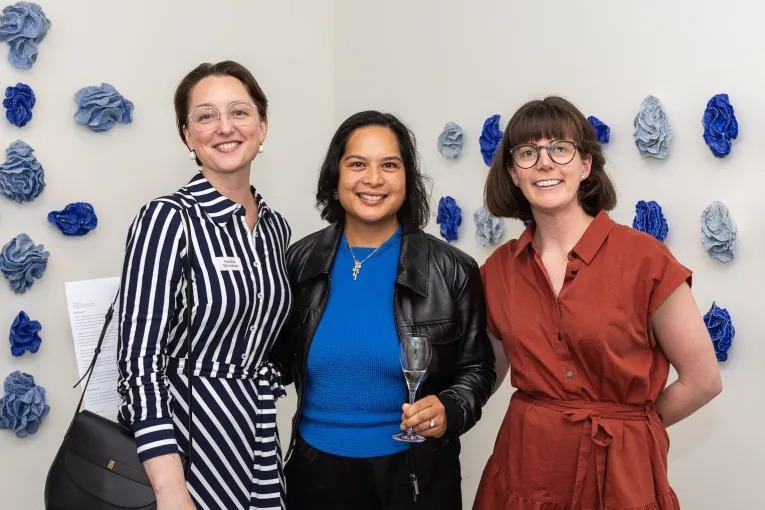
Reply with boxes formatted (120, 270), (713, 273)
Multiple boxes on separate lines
(69, 203), (195, 471)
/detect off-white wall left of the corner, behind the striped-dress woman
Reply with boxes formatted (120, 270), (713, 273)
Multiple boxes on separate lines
(0, 0), (334, 510)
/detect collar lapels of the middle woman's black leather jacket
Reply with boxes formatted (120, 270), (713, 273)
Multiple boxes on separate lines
(297, 223), (430, 297)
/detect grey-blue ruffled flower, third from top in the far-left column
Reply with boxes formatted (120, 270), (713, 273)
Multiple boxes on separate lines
(0, 140), (45, 202)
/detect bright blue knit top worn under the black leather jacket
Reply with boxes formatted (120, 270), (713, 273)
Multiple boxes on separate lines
(299, 228), (409, 458)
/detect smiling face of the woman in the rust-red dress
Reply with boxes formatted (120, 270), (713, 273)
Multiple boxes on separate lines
(509, 138), (592, 214)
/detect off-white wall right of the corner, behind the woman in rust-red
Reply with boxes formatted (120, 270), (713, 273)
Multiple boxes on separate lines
(335, 0), (765, 510)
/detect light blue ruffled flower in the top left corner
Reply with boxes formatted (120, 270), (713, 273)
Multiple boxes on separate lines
(0, 2), (50, 69)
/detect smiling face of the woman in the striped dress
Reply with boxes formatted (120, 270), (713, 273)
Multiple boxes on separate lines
(183, 76), (268, 178)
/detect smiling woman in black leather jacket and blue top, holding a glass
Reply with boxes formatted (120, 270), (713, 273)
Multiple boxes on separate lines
(273, 111), (495, 510)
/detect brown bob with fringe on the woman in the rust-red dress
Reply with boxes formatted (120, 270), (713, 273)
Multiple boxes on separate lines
(484, 96), (616, 221)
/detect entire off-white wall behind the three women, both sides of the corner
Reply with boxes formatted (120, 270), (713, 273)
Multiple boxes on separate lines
(0, 0), (765, 510)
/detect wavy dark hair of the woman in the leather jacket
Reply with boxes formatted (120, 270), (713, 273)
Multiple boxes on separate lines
(316, 110), (430, 228)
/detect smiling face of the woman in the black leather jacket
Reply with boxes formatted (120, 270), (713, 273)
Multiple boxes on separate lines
(337, 126), (406, 241)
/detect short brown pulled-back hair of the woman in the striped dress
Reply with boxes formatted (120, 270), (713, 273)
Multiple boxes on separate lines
(173, 60), (268, 166)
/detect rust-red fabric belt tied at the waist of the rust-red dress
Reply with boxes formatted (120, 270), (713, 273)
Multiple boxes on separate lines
(513, 391), (656, 510)
